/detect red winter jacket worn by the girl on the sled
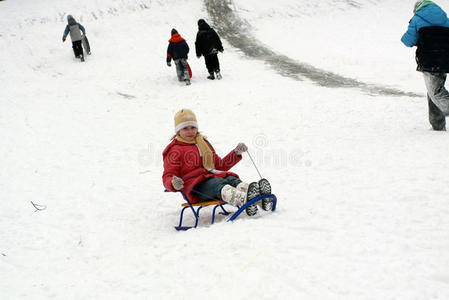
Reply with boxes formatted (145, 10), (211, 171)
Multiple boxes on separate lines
(162, 140), (242, 203)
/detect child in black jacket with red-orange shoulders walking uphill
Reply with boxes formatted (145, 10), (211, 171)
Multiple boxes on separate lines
(167, 28), (190, 85)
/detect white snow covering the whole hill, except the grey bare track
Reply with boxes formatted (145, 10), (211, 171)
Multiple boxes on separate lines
(0, 0), (449, 300)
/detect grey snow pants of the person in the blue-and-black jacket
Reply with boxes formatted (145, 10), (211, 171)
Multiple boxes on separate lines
(423, 72), (449, 130)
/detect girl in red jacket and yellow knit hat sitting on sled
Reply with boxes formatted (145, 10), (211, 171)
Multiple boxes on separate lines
(162, 109), (272, 216)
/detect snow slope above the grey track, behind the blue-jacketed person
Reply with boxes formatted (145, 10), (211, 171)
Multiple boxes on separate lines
(234, 0), (449, 93)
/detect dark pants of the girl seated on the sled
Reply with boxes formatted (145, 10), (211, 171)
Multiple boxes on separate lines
(192, 176), (242, 201)
